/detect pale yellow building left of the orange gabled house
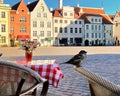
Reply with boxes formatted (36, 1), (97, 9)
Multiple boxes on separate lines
(0, 2), (10, 46)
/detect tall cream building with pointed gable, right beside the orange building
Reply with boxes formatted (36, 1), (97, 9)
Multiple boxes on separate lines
(27, 0), (53, 46)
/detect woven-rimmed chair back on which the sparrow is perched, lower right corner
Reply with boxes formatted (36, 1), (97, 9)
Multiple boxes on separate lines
(75, 67), (120, 96)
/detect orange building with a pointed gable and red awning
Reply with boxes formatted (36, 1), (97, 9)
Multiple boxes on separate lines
(10, 0), (30, 45)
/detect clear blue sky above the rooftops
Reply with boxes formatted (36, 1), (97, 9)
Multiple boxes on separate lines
(4, 0), (120, 15)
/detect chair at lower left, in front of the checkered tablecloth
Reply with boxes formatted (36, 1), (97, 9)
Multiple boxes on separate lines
(0, 61), (49, 96)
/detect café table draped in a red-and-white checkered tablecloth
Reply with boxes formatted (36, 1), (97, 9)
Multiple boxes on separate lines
(15, 60), (64, 88)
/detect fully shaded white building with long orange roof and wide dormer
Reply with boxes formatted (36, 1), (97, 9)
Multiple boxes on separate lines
(79, 7), (114, 46)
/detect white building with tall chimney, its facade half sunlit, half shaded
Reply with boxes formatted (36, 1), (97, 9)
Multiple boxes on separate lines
(52, 0), (84, 45)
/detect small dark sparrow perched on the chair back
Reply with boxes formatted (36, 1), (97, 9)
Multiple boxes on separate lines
(64, 50), (87, 67)
